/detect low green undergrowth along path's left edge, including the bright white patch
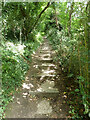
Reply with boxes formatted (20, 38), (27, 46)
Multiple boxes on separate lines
(0, 32), (43, 118)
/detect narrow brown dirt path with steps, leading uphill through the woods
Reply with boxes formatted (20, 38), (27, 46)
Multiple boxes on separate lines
(5, 39), (69, 119)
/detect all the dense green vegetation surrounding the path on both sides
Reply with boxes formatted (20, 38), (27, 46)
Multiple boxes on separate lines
(0, 2), (90, 119)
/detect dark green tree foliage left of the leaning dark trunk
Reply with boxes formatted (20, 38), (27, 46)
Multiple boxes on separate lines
(2, 2), (46, 41)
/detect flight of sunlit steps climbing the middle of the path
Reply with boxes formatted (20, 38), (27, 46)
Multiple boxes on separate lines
(29, 42), (59, 96)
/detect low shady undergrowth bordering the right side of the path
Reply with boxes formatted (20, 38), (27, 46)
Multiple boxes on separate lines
(47, 28), (89, 119)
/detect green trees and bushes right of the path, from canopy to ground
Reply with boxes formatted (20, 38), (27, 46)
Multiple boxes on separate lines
(45, 3), (89, 118)
